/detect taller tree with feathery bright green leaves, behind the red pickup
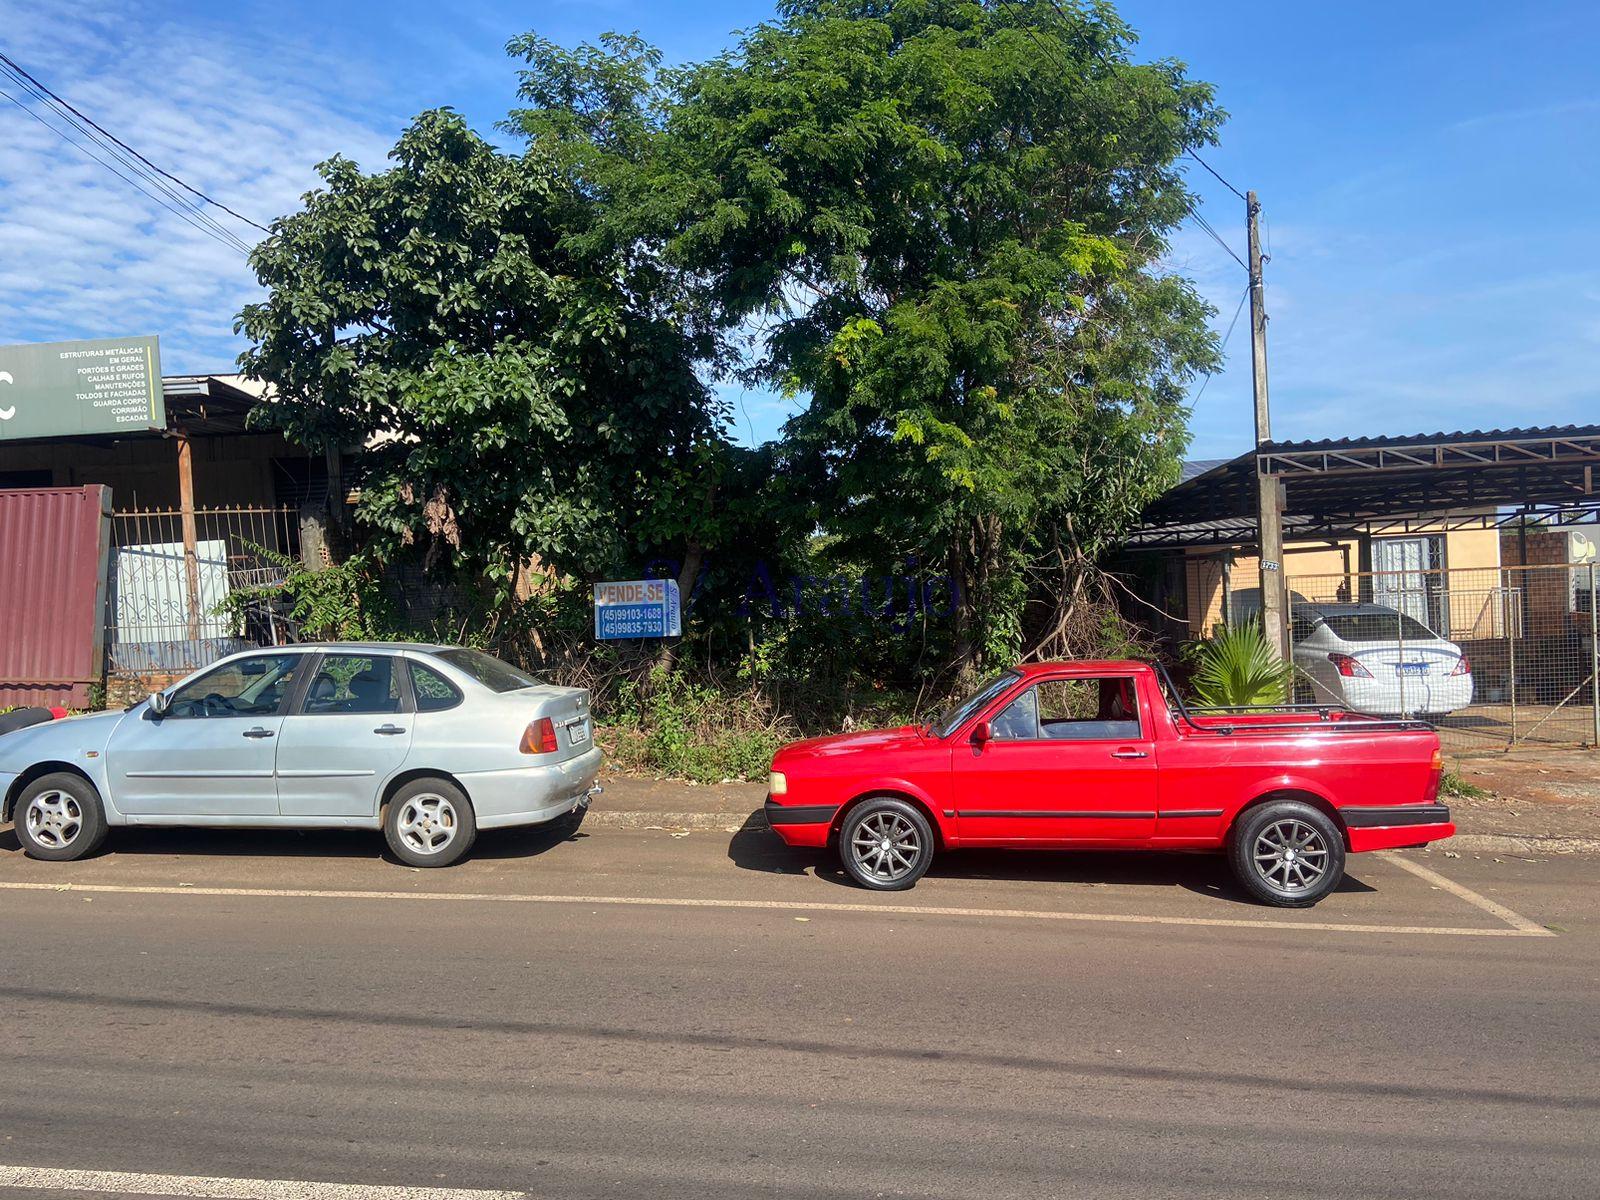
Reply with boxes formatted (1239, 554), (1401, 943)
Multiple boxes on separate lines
(512, 0), (1221, 669)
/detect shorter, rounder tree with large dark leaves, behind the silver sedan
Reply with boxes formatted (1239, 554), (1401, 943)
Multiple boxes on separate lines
(238, 110), (733, 598)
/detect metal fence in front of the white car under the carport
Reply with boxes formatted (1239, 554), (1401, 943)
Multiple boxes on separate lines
(1288, 563), (1600, 750)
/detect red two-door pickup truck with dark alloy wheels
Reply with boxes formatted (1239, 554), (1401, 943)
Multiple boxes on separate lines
(766, 662), (1456, 907)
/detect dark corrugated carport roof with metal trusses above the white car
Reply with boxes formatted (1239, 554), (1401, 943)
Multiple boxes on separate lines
(1130, 426), (1600, 547)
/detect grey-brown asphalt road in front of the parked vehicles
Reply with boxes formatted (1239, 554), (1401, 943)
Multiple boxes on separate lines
(0, 827), (1600, 1200)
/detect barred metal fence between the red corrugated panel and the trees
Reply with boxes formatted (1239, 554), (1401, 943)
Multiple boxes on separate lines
(106, 509), (299, 688)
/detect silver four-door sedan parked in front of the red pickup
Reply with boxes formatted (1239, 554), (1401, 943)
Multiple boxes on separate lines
(0, 643), (600, 867)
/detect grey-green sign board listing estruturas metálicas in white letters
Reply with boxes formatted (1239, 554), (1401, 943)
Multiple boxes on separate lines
(0, 338), (166, 442)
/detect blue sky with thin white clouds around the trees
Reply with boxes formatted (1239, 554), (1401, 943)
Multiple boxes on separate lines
(0, 0), (1600, 458)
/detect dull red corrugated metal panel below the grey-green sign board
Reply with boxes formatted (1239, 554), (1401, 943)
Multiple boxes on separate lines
(0, 483), (110, 709)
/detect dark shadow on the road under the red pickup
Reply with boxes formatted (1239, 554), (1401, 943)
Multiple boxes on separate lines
(728, 811), (1376, 907)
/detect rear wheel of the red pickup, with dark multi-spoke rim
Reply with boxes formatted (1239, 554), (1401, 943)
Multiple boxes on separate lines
(1227, 800), (1344, 909)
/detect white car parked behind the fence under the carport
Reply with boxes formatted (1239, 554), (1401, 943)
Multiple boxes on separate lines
(1290, 602), (1472, 717)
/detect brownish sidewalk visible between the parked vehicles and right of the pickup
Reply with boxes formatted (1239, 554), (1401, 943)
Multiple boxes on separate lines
(587, 771), (1600, 858)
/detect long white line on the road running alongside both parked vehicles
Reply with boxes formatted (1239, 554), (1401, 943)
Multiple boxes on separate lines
(0, 882), (1554, 938)
